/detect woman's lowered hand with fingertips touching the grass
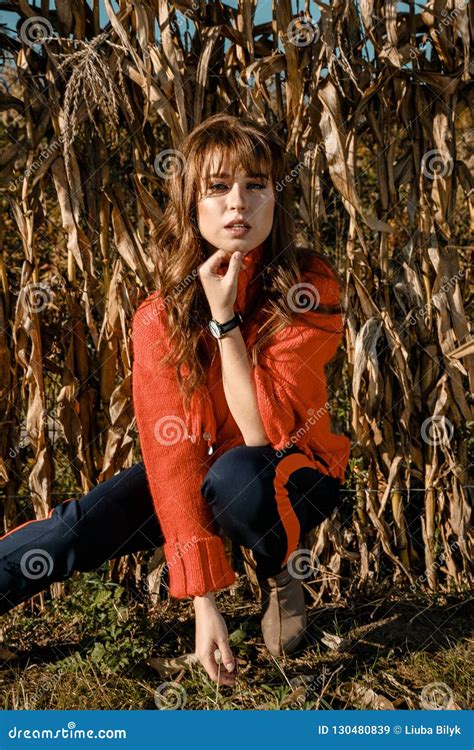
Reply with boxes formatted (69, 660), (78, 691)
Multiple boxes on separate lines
(194, 594), (235, 685)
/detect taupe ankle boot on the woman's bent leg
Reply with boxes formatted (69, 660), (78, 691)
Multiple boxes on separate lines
(259, 568), (306, 656)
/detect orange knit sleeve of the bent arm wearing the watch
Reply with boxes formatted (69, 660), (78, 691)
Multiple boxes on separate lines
(252, 264), (349, 478)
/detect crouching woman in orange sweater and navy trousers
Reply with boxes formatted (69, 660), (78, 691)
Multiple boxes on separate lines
(0, 115), (350, 684)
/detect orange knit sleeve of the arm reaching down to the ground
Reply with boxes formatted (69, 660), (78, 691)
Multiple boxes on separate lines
(132, 298), (236, 598)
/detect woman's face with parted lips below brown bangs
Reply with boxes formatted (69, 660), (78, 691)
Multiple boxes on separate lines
(196, 160), (275, 256)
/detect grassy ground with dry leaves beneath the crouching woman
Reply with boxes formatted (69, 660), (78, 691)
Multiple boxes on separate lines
(0, 568), (474, 710)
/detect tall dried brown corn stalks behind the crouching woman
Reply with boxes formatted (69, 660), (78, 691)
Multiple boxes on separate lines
(0, 0), (474, 602)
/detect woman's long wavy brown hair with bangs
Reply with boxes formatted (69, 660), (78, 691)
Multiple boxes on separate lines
(143, 114), (340, 412)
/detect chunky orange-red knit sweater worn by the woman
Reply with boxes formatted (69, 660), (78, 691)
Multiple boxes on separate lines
(132, 247), (350, 598)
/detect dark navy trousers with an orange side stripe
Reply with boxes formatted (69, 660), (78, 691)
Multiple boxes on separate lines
(0, 445), (340, 613)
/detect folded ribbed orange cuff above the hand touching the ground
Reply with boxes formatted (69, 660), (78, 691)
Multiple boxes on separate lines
(163, 536), (236, 599)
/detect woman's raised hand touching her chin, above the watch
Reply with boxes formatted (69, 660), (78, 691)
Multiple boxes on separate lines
(198, 250), (244, 323)
